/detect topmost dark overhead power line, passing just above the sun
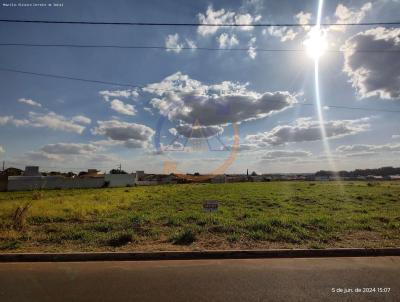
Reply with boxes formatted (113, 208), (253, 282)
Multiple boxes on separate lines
(0, 19), (400, 27)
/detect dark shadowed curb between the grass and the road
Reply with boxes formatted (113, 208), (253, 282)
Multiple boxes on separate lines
(0, 248), (400, 262)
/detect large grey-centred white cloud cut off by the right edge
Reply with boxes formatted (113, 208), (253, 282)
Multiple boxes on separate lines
(342, 27), (400, 99)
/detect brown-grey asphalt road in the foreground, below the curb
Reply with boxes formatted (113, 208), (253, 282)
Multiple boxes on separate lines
(0, 257), (400, 302)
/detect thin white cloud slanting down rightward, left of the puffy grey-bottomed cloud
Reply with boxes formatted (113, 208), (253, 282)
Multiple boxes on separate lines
(29, 112), (85, 134)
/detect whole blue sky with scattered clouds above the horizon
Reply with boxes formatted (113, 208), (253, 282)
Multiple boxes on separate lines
(0, 0), (400, 173)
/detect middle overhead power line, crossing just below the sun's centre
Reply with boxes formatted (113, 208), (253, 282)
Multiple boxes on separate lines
(0, 43), (400, 53)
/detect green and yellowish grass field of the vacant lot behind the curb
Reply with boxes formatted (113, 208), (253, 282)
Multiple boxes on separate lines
(0, 182), (400, 252)
